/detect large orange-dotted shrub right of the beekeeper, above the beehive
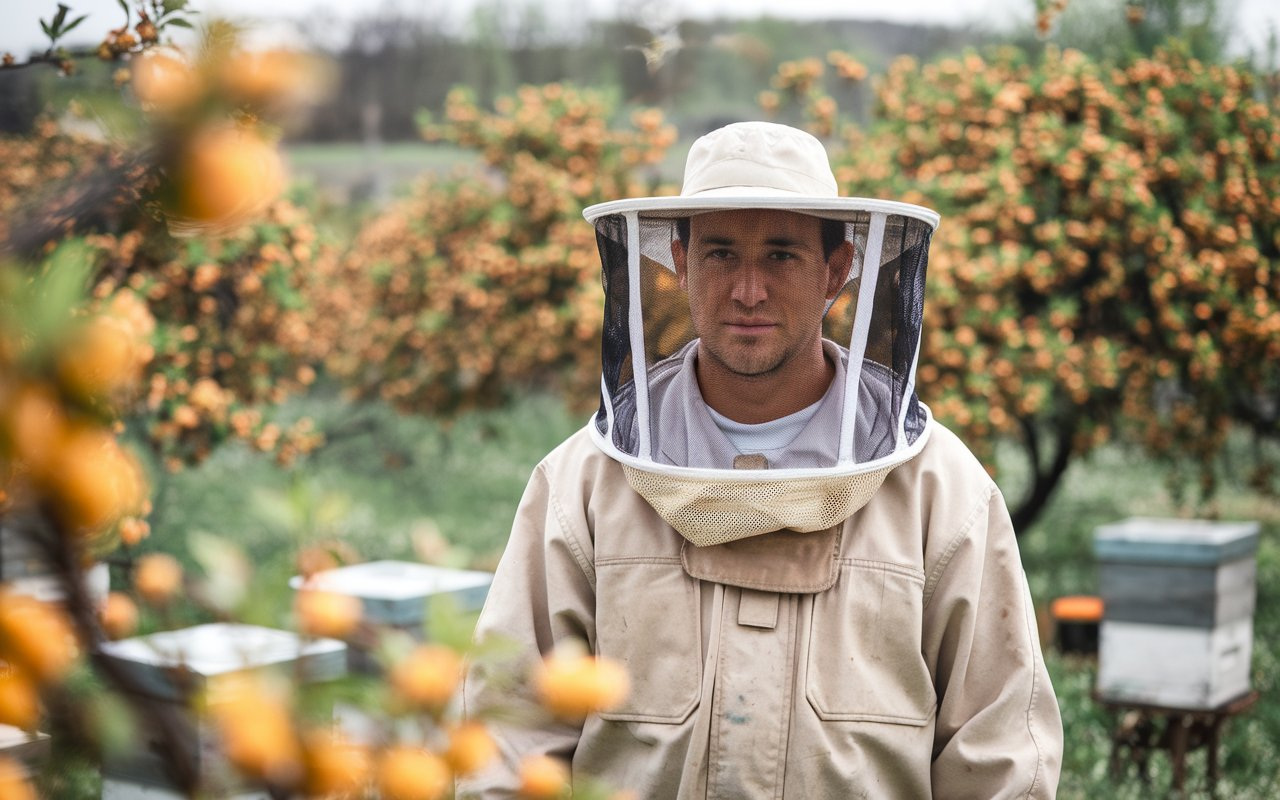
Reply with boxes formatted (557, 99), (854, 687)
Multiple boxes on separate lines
(837, 47), (1280, 524)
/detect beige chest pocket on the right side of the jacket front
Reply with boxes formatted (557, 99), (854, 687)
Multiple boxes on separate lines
(805, 559), (937, 726)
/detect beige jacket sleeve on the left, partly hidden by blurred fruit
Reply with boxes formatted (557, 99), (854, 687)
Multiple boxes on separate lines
(457, 465), (595, 799)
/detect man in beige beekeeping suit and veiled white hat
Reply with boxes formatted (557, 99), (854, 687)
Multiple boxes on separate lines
(460, 122), (1062, 800)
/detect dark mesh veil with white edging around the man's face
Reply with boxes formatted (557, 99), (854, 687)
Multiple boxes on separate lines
(588, 198), (936, 471)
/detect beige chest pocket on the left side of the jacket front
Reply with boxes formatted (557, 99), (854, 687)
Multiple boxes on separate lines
(595, 558), (703, 723)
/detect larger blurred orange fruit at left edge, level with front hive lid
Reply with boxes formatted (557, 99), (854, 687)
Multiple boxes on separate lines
(0, 594), (79, 684)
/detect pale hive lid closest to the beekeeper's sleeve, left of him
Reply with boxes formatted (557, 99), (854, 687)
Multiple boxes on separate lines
(289, 561), (493, 625)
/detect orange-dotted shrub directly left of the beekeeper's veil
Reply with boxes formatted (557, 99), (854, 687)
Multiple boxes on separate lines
(316, 84), (676, 412)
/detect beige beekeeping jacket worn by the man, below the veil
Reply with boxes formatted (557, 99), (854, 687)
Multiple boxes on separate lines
(460, 424), (1062, 799)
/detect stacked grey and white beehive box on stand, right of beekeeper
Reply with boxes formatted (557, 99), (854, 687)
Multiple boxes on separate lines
(1093, 517), (1258, 709)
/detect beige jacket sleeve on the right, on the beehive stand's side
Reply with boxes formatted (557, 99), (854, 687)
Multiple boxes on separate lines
(924, 485), (1062, 799)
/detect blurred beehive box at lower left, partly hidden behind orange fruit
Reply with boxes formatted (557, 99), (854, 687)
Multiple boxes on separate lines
(101, 622), (347, 797)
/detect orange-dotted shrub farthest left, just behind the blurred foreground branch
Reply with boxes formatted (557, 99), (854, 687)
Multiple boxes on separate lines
(83, 200), (334, 468)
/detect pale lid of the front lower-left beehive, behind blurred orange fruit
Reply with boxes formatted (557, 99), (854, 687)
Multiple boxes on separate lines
(100, 622), (347, 700)
